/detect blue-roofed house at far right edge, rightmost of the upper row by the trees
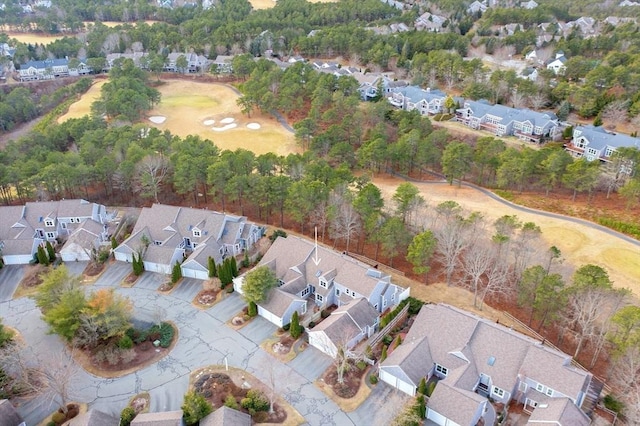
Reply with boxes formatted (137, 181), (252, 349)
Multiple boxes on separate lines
(565, 125), (640, 166)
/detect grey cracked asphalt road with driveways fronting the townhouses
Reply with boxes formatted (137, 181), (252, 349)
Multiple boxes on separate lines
(0, 263), (406, 426)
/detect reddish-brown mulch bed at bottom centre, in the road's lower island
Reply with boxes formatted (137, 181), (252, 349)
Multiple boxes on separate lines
(193, 373), (287, 423)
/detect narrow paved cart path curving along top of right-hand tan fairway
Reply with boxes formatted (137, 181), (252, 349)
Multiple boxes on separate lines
(391, 172), (640, 247)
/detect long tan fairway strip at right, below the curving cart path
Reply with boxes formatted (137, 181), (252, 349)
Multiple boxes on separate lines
(374, 176), (640, 297)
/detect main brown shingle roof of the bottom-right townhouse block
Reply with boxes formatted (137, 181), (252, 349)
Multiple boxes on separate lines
(381, 304), (591, 400)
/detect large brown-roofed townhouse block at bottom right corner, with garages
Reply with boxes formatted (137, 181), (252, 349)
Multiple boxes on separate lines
(379, 304), (602, 426)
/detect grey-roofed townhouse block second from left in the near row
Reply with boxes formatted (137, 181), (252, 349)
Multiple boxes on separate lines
(113, 204), (264, 280)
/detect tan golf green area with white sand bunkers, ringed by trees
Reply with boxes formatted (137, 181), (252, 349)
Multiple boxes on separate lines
(148, 80), (298, 155)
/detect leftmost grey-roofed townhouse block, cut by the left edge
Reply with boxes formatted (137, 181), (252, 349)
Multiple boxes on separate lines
(0, 199), (115, 265)
